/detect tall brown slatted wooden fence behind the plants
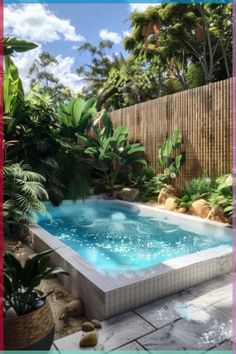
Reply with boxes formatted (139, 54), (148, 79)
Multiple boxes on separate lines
(111, 79), (233, 186)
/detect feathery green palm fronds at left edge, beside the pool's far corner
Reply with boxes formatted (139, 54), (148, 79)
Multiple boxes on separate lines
(3, 161), (48, 236)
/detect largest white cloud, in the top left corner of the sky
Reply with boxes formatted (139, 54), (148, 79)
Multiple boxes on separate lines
(4, 4), (85, 43)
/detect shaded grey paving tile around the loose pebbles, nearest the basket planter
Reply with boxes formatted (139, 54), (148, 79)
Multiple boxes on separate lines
(55, 311), (154, 351)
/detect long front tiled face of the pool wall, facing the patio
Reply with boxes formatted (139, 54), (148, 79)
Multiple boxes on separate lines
(103, 254), (232, 318)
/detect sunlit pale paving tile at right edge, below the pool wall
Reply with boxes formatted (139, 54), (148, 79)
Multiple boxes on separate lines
(186, 274), (232, 305)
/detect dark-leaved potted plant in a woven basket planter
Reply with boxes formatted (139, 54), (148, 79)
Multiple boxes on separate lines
(4, 250), (68, 350)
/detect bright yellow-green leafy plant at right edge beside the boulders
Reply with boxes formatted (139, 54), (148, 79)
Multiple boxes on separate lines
(208, 174), (233, 217)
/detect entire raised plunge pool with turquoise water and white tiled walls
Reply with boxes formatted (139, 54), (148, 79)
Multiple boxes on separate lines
(31, 197), (232, 320)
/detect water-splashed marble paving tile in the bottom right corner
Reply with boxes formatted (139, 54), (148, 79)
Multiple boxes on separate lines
(138, 306), (232, 350)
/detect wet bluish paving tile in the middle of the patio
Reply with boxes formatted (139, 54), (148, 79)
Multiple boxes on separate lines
(135, 293), (201, 328)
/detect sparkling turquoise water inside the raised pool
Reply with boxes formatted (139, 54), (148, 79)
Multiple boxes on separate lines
(38, 200), (231, 271)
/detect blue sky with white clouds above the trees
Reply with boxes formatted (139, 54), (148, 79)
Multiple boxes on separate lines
(4, 3), (153, 92)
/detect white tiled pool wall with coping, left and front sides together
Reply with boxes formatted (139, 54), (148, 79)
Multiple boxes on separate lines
(30, 224), (232, 320)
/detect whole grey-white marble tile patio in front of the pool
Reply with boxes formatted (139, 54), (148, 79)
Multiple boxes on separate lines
(54, 275), (232, 352)
